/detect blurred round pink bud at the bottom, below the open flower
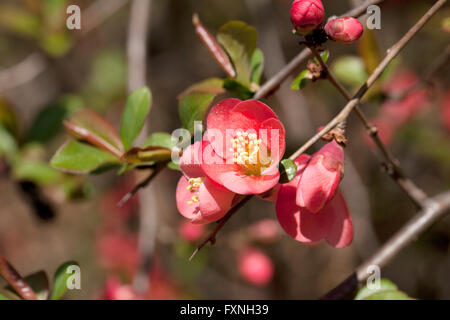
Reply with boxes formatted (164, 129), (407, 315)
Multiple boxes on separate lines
(238, 248), (274, 286)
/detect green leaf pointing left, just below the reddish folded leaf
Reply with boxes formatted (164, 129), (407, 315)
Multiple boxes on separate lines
(50, 140), (119, 173)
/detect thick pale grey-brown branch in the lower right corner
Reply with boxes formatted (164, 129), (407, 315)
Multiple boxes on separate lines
(321, 191), (450, 300)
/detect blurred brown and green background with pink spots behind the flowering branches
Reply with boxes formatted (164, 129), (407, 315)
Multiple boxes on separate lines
(0, 0), (450, 299)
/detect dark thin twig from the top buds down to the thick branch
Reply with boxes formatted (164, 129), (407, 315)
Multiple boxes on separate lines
(310, 47), (427, 208)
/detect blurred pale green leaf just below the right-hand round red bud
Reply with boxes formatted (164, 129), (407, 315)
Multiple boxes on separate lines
(331, 56), (368, 87)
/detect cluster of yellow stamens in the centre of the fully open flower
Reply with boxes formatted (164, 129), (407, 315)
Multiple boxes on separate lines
(230, 132), (270, 175)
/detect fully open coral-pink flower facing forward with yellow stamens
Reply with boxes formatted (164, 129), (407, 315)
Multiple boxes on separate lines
(202, 99), (285, 194)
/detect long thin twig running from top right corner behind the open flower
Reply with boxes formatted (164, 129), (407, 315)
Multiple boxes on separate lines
(191, 0), (447, 258)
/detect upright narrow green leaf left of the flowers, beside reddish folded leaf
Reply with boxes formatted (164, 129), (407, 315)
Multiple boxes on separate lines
(120, 87), (152, 150)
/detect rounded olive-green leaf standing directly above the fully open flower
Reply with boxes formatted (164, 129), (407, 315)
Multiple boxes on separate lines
(217, 21), (258, 87)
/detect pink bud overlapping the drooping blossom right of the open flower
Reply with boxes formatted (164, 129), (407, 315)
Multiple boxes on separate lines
(296, 140), (344, 213)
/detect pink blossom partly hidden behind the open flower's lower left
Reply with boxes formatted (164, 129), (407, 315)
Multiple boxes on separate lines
(176, 142), (235, 224)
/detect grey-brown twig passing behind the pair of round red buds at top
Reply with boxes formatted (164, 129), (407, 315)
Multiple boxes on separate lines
(254, 0), (384, 99)
